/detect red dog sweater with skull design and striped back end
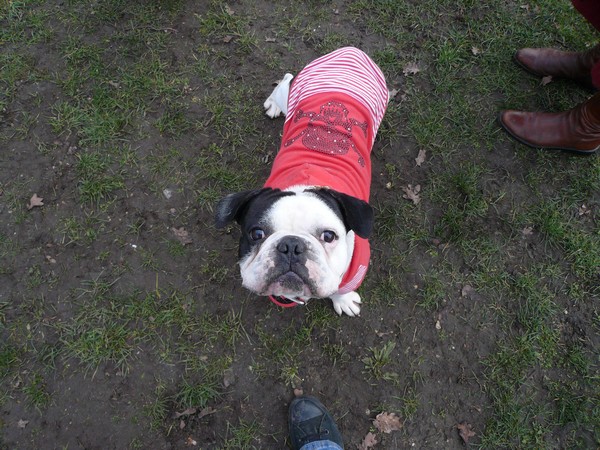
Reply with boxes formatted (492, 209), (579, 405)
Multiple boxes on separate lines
(265, 47), (388, 294)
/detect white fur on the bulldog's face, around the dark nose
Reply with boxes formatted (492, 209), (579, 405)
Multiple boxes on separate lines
(240, 187), (354, 298)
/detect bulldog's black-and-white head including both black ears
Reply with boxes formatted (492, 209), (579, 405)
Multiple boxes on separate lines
(216, 187), (373, 299)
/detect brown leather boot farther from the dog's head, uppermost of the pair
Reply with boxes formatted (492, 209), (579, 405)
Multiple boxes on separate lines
(515, 44), (600, 90)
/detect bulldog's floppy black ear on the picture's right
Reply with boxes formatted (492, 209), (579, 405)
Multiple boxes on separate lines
(309, 188), (374, 239)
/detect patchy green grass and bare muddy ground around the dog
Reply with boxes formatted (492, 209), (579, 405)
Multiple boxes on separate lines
(0, 0), (600, 448)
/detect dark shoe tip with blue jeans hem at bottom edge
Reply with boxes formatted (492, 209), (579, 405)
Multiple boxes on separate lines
(289, 396), (344, 450)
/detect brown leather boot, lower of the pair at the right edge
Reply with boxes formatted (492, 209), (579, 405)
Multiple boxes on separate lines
(499, 92), (600, 154)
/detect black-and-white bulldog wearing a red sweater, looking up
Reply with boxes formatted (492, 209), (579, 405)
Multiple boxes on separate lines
(216, 47), (389, 316)
